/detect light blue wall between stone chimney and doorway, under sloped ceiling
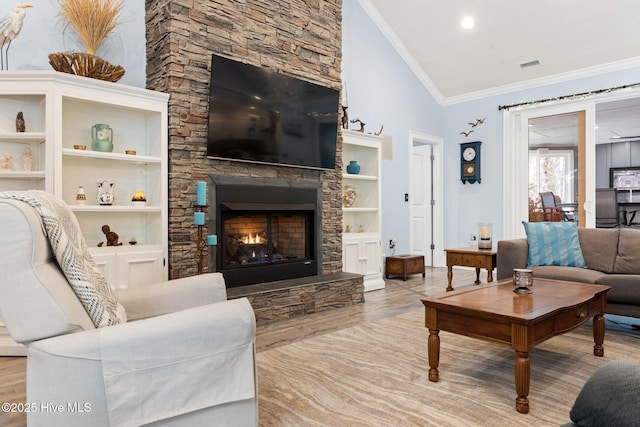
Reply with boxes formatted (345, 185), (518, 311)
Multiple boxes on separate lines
(342, 0), (442, 255)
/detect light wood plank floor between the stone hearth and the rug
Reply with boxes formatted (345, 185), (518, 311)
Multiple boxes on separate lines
(0, 268), (478, 427)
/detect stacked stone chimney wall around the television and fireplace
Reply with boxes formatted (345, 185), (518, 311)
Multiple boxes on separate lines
(146, 0), (342, 279)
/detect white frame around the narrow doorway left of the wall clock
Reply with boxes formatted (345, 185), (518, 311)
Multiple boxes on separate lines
(407, 131), (446, 267)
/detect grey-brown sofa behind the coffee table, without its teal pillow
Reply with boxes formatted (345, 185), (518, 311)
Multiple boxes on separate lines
(497, 228), (640, 318)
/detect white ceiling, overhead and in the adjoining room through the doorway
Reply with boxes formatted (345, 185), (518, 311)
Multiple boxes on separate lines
(359, 0), (640, 143)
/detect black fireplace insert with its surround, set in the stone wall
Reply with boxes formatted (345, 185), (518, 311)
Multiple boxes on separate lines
(210, 178), (321, 287)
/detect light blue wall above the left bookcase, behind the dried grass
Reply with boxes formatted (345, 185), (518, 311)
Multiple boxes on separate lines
(5, 0), (147, 87)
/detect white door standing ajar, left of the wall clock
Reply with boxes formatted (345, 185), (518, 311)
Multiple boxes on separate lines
(409, 144), (433, 266)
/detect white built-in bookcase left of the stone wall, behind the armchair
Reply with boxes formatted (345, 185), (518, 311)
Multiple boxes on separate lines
(0, 71), (169, 298)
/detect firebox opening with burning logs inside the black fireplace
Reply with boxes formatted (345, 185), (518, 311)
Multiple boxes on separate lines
(222, 211), (313, 270)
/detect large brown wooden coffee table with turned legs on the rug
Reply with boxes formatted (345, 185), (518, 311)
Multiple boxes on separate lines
(421, 278), (609, 414)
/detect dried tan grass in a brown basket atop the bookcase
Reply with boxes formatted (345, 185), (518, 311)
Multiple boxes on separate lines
(49, 0), (124, 82)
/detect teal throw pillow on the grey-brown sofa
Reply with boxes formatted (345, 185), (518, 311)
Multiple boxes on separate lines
(522, 221), (586, 268)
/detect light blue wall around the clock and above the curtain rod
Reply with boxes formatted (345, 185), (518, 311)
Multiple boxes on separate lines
(443, 68), (640, 247)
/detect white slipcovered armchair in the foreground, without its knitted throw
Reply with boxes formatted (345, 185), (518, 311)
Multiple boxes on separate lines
(0, 192), (258, 426)
